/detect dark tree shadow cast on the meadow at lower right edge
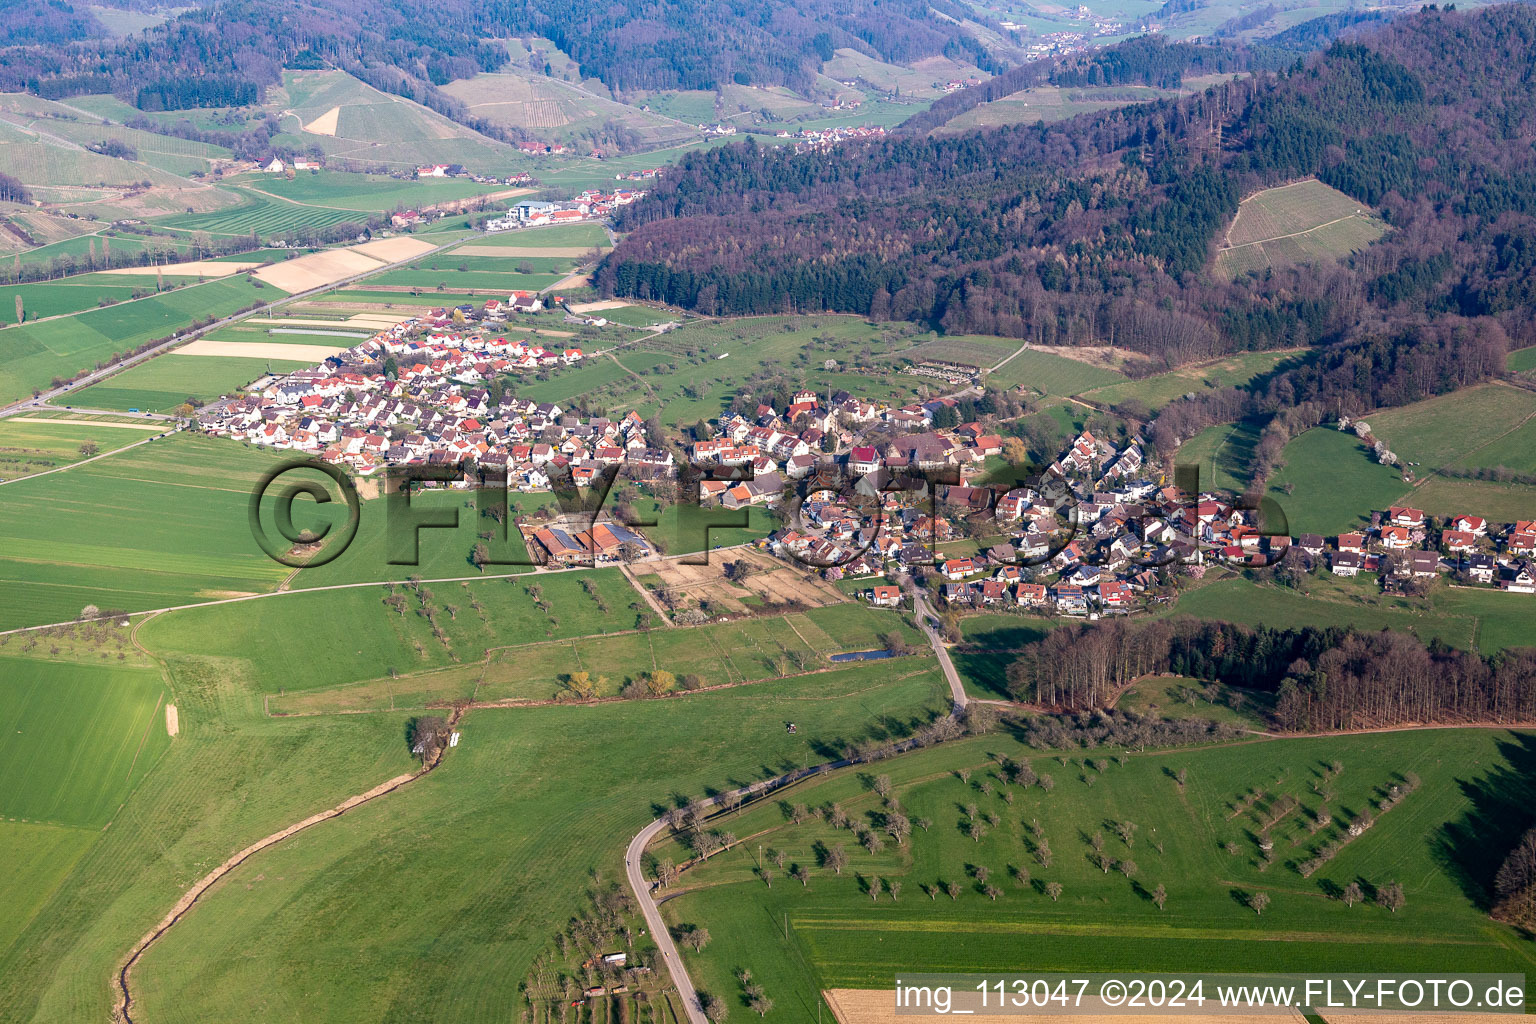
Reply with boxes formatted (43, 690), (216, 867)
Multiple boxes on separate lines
(1430, 734), (1536, 910)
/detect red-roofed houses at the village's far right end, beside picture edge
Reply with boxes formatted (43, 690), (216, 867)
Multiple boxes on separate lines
(1320, 505), (1536, 594)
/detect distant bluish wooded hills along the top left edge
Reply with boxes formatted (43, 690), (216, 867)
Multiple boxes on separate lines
(0, 0), (1001, 106)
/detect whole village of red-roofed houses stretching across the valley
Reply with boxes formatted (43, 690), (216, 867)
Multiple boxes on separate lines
(197, 300), (1536, 617)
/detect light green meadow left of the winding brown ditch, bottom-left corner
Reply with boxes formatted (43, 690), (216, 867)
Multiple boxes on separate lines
(0, 656), (412, 1024)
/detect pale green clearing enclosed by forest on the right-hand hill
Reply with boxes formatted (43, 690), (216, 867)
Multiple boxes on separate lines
(1215, 178), (1387, 278)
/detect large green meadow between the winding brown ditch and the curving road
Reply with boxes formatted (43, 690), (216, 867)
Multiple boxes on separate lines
(125, 662), (945, 1022)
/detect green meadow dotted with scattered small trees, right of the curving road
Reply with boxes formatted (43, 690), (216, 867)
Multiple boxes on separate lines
(653, 729), (1536, 1021)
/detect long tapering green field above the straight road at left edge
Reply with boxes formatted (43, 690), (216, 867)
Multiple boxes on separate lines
(0, 276), (273, 402)
